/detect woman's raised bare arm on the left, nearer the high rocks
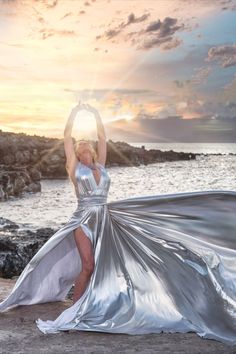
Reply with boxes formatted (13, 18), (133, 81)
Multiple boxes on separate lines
(64, 102), (84, 174)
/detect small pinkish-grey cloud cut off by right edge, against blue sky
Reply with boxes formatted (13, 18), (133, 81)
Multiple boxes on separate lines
(206, 44), (236, 68)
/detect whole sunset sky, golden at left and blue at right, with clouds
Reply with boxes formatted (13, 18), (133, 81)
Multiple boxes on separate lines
(0, 0), (236, 143)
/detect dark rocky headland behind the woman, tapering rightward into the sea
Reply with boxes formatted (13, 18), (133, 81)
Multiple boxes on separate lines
(0, 130), (197, 201)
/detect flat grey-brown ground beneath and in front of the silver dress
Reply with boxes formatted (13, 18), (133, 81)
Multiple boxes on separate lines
(0, 279), (236, 354)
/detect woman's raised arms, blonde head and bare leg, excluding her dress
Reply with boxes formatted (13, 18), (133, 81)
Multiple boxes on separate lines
(64, 102), (106, 302)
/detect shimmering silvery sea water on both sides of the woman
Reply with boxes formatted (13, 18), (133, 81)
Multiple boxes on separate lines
(0, 143), (236, 229)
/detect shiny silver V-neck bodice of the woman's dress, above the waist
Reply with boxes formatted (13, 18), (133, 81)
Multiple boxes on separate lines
(75, 161), (111, 202)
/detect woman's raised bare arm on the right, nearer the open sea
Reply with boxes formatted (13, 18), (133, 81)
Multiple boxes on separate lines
(85, 104), (107, 166)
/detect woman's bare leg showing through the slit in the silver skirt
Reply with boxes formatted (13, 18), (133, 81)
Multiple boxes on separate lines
(73, 227), (94, 303)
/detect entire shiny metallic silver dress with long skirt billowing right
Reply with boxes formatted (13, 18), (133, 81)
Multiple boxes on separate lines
(0, 162), (236, 345)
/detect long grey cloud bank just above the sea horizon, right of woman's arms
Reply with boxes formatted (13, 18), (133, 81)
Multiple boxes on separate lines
(106, 115), (236, 143)
